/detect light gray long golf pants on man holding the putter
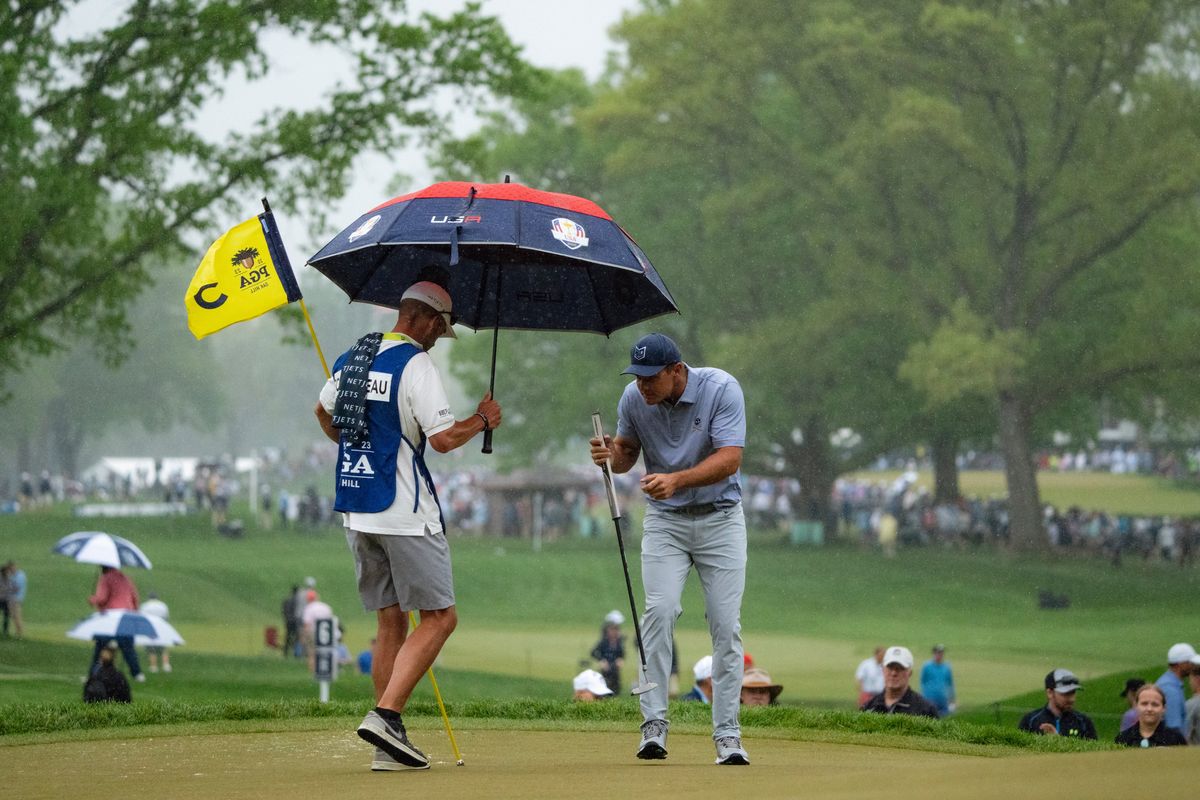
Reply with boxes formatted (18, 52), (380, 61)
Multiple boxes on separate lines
(641, 504), (746, 739)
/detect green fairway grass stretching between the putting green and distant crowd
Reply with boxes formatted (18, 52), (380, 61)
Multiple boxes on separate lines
(0, 503), (1200, 743)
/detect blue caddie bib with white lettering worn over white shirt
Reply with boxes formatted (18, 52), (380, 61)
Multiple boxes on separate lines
(334, 343), (436, 513)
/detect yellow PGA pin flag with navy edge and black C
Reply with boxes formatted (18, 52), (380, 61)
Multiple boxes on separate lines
(184, 210), (301, 339)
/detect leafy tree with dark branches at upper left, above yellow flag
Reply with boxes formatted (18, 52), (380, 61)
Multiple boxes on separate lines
(0, 0), (528, 391)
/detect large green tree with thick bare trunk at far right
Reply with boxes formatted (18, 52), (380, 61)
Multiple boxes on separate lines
(840, 0), (1200, 549)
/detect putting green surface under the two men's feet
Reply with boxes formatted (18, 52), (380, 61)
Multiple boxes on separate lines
(0, 720), (1200, 800)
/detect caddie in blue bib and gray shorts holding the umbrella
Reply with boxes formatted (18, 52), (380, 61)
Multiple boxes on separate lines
(316, 282), (500, 771)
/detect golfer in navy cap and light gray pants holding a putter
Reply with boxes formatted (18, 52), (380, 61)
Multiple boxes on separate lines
(590, 333), (750, 764)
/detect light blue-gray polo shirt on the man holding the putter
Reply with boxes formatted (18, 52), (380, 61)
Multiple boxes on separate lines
(617, 365), (746, 509)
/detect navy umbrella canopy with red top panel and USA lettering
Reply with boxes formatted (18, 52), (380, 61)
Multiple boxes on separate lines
(308, 181), (678, 335)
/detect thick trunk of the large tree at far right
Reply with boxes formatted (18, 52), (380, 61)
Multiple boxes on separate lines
(1000, 393), (1050, 553)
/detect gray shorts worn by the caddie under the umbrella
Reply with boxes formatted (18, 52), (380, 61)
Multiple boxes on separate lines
(346, 528), (454, 612)
